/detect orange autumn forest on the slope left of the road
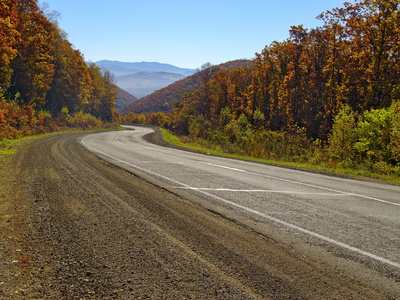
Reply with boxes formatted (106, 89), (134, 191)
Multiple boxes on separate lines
(0, 0), (119, 140)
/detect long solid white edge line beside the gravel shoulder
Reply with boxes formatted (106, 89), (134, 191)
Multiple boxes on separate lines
(81, 136), (400, 268)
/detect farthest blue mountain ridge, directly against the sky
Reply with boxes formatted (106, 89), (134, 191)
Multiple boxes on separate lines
(95, 60), (197, 76)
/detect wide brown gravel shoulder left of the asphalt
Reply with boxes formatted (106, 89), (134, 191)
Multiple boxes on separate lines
(0, 133), (394, 299)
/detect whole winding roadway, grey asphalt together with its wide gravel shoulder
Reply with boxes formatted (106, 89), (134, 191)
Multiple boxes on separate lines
(4, 127), (400, 299)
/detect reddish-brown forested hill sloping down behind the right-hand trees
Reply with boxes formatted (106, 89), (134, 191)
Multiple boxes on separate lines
(119, 60), (251, 115)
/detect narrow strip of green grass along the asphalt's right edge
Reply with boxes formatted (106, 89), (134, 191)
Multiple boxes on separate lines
(161, 129), (400, 184)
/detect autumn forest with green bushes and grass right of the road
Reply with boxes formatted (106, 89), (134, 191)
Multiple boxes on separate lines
(123, 0), (400, 176)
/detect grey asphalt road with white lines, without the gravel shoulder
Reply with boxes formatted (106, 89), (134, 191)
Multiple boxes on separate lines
(81, 127), (400, 295)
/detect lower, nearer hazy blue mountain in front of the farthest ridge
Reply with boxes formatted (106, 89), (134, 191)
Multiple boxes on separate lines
(116, 72), (185, 98)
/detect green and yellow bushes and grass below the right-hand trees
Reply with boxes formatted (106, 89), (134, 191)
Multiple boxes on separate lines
(162, 101), (400, 183)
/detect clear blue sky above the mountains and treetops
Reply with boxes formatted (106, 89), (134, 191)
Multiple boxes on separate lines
(39, 0), (346, 69)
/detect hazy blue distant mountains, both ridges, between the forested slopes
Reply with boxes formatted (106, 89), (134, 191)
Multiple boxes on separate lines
(95, 60), (197, 98)
